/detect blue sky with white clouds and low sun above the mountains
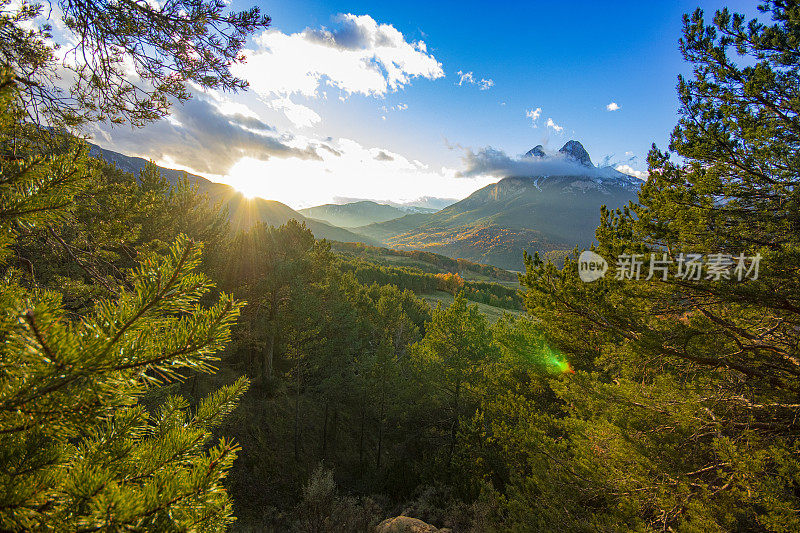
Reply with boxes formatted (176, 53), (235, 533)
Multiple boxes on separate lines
(84, 0), (755, 208)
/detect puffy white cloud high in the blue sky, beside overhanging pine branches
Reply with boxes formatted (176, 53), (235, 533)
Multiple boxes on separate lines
(239, 14), (444, 98)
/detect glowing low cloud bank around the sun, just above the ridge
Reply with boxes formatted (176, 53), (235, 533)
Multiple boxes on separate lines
(90, 90), (497, 208)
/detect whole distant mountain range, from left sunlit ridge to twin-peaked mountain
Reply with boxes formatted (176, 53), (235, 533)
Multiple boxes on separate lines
(92, 140), (642, 270)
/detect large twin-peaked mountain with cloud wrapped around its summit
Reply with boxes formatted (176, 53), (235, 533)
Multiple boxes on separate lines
(353, 141), (641, 270)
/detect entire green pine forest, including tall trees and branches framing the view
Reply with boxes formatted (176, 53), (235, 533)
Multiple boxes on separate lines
(0, 0), (800, 533)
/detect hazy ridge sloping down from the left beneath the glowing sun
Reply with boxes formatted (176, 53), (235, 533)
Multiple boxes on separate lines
(89, 143), (376, 245)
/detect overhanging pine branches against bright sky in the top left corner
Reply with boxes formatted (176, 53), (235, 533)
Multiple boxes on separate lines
(0, 0), (270, 127)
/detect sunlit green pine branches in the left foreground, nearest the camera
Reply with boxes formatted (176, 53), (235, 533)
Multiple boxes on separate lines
(0, 65), (247, 531)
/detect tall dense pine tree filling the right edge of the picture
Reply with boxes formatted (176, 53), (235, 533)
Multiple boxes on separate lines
(517, 1), (800, 531)
